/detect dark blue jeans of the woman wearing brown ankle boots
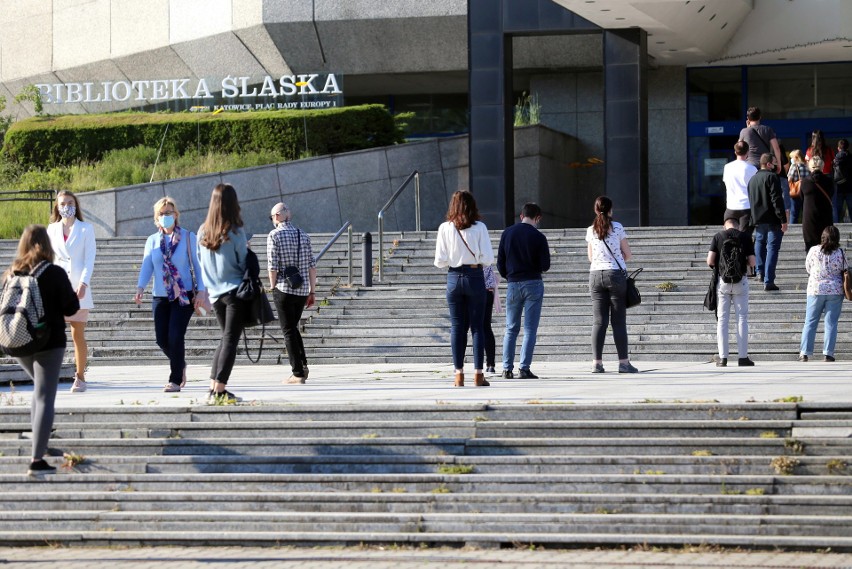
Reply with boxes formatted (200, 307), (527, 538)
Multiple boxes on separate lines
(447, 266), (485, 369)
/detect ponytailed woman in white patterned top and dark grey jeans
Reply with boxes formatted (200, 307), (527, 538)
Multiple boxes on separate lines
(586, 196), (639, 373)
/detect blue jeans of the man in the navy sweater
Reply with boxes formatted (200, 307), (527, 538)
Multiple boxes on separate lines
(503, 279), (544, 371)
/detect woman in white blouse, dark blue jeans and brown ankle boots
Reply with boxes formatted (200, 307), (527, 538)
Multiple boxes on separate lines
(435, 191), (494, 387)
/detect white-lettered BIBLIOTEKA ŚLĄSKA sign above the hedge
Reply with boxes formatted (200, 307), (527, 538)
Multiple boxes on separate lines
(36, 73), (343, 110)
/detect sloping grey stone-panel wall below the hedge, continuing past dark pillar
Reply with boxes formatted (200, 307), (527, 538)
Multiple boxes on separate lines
(79, 127), (581, 237)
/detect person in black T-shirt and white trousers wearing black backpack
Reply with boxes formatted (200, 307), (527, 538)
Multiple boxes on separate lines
(707, 216), (755, 367)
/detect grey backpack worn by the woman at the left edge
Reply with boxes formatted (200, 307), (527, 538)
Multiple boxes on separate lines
(0, 261), (50, 356)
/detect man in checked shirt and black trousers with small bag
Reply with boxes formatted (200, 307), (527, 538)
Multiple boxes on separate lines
(266, 202), (317, 383)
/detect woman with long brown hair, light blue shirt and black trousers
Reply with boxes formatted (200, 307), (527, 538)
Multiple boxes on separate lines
(198, 184), (248, 403)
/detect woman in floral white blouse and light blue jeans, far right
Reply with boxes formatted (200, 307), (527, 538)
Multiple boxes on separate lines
(799, 225), (846, 362)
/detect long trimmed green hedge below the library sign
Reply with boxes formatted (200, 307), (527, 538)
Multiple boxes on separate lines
(3, 105), (403, 168)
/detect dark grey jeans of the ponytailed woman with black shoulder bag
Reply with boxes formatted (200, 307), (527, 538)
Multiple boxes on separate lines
(589, 270), (630, 360)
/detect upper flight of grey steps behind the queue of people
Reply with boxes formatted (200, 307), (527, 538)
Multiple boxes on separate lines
(0, 225), (852, 374)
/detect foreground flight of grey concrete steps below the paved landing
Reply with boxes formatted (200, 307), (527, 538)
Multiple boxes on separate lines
(0, 403), (852, 550)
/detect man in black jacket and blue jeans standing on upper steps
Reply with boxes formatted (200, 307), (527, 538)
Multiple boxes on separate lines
(748, 154), (787, 291)
